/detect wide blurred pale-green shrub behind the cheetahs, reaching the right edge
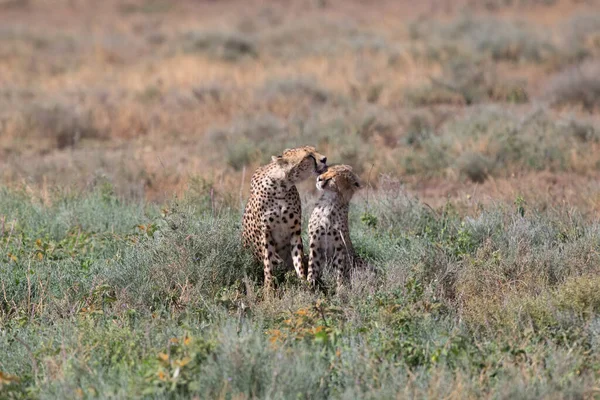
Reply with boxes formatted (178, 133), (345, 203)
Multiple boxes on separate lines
(400, 107), (597, 179)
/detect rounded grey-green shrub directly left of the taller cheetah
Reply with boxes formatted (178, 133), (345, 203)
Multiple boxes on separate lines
(106, 206), (255, 309)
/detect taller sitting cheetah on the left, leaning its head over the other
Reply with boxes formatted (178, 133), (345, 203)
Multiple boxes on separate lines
(242, 146), (327, 287)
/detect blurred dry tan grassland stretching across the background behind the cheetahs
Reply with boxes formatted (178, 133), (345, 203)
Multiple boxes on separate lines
(0, 0), (600, 212)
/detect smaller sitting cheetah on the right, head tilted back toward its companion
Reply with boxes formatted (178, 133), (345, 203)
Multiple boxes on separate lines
(308, 165), (364, 285)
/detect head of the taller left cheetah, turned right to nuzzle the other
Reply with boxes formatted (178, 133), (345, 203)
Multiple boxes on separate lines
(273, 146), (327, 183)
